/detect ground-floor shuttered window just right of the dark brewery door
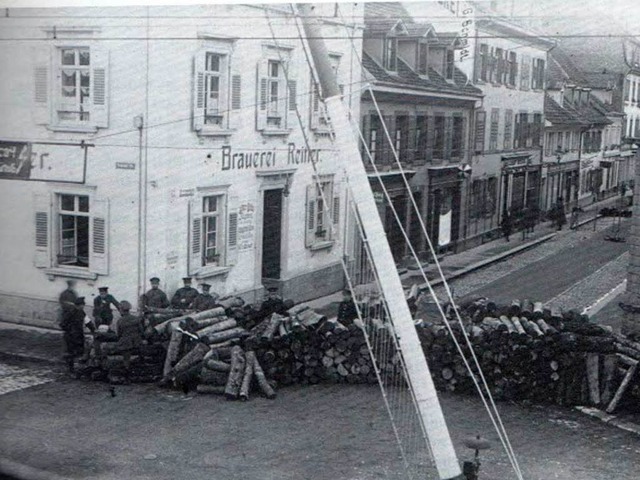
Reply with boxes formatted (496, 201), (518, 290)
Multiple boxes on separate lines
(305, 176), (340, 250)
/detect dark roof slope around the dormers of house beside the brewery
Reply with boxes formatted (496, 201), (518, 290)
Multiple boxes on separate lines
(362, 52), (482, 97)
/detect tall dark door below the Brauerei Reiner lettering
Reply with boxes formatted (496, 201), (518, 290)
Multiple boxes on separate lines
(262, 189), (282, 278)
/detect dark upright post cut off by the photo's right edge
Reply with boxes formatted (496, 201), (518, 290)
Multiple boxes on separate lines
(620, 148), (640, 337)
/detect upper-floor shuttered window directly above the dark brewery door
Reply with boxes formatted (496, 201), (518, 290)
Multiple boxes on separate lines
(256, 50), (296, 135)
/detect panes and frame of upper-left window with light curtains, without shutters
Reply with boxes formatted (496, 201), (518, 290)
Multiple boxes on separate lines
(58, 48), (91, 122)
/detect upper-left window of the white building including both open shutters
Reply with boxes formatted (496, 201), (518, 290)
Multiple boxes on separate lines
(33, 46), (109, 132)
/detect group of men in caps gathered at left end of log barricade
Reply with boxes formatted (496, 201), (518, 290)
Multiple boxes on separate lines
(58, 277), (219, 371)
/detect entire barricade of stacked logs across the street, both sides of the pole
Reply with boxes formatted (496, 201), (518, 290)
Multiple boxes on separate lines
(79, 290), (640, 410)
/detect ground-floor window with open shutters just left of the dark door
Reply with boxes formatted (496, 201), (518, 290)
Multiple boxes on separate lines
(189, 189), (238, 278)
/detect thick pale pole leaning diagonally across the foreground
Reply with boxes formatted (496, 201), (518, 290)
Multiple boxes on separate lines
(297, 3), (464, 480)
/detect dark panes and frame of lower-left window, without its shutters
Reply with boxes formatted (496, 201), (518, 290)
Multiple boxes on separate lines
(57, 195), (90, 267)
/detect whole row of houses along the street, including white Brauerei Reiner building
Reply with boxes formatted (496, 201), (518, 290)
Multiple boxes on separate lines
(0, 2), (640, 326)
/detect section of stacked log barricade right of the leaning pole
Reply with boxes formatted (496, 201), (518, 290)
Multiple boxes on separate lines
(418, 299), (640, 407)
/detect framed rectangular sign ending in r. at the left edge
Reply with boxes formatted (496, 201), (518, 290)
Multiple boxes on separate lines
(0, 140), (85, 183)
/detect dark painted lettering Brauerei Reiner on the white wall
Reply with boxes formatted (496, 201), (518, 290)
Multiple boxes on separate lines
(219, 143), (321, 170)
